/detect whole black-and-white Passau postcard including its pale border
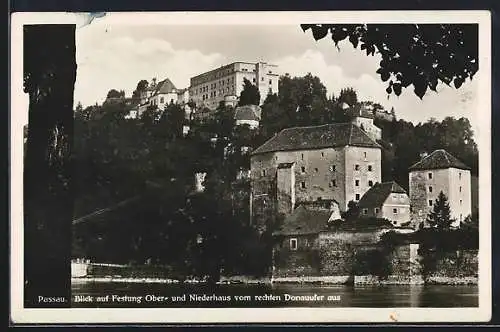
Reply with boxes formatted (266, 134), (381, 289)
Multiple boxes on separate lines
(11, 11), (491, 323)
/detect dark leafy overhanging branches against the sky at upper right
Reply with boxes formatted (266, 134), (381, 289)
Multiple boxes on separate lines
(301, 24), (479, 99)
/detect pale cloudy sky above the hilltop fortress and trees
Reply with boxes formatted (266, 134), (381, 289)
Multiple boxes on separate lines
(18, 16), (479, 135)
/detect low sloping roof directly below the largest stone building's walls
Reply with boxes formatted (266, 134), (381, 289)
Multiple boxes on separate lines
(274, 205), (332, 235)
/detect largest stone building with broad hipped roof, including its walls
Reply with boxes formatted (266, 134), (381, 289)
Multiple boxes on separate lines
(250, 123), (381, 228)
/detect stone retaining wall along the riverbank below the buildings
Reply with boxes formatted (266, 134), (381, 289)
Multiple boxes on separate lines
(273, 231), (478, 284)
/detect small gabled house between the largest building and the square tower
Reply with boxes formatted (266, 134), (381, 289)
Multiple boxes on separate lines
(358, 181), (410, 226)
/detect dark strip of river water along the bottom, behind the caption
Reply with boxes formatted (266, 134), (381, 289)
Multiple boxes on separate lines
(72, 282), (478, 308)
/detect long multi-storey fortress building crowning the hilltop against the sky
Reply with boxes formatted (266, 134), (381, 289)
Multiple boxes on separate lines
(189, 62), (279, 109)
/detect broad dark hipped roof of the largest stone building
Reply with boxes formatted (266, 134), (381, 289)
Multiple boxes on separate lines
(252, 123), (380, 154)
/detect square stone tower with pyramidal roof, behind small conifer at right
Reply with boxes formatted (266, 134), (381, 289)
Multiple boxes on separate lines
(409, 149), (471, 227)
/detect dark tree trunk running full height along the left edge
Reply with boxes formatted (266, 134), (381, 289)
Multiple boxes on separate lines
(23, 24), (76, 307)
